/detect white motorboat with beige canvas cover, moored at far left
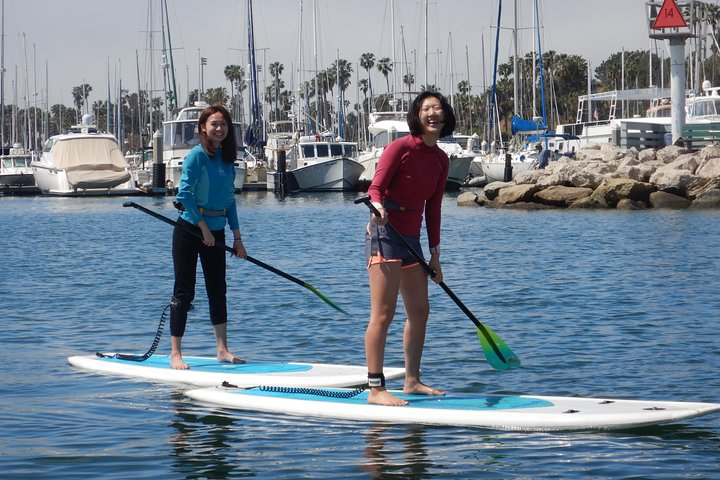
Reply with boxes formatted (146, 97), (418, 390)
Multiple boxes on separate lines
(31, 114), (140, 196)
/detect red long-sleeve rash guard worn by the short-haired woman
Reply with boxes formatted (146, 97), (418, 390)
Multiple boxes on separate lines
(368, 135), (450, 248)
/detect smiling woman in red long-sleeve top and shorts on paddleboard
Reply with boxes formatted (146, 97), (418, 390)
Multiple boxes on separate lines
(365, 91), (455, 406)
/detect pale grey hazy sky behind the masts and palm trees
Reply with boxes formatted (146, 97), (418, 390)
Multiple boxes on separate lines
(4, 0), (684, 109)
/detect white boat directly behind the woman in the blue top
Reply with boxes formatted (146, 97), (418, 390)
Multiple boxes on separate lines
(163, 102), (245, 192)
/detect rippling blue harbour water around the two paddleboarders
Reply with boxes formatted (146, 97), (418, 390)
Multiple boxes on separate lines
(0, 192), (720, 479)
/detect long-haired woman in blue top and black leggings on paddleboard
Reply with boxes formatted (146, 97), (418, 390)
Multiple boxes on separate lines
(170, 105), (247, 370)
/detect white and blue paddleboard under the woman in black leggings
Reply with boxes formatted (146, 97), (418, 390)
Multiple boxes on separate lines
(68, 354), (405, 387)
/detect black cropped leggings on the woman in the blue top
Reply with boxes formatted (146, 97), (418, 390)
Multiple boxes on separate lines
(170, 218), (227, 337)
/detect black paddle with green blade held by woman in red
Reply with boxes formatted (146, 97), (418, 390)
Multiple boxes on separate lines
(355, 195), (520, 370)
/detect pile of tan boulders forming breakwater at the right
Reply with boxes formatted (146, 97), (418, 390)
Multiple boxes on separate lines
(457, 144), (720, 210)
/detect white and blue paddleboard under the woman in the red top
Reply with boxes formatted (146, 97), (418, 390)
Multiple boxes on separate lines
(186, 387), (720, 431)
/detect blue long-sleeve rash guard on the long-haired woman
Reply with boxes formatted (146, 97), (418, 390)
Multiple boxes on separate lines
(176, 145), (240, 230)
